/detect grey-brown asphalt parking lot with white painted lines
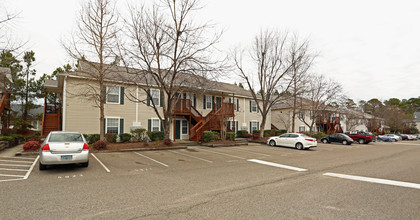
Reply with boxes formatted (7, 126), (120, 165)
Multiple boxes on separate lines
(0, 141), (420, 219)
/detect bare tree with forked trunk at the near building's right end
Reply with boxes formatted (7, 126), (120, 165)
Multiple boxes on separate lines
(234, 30), (307, 137)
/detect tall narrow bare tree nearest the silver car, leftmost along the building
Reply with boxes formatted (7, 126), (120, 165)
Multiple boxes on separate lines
(63, 0), (119, 140)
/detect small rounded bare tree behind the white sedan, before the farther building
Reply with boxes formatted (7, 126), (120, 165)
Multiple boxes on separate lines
(297, 75), (342, 133)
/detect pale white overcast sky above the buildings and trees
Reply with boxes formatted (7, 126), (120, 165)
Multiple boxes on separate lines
(4, 0), (420, 101)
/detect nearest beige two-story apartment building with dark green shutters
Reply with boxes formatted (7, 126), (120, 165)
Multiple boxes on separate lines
(42, 62), (271, 140)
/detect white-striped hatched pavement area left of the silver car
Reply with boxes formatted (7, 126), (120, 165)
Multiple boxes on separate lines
(0, 157), (38, 182)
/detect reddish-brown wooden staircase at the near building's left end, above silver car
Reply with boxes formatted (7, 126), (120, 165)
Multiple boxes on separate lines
(41, 103), (61, 137)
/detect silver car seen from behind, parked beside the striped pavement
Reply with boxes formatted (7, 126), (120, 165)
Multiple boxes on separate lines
(39, 131), (89, 170)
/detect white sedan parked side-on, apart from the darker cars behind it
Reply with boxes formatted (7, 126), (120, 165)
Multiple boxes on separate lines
(267, 133), (318, 150)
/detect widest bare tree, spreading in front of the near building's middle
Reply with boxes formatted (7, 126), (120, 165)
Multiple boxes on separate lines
(122, 0), (223, 139)
